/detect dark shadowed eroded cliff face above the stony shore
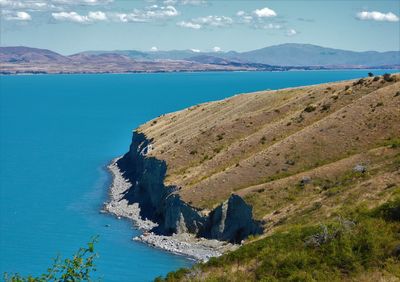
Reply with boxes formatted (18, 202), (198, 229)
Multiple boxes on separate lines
(117, 132), (262, 242)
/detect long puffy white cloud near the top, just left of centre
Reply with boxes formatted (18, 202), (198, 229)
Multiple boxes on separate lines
(111, 5), (179, 23)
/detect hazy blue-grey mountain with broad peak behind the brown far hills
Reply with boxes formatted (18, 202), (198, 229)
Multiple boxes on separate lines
(76, 43), (400, 68)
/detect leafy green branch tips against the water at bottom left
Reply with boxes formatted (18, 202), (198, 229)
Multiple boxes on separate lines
(4, 237), (97, 282)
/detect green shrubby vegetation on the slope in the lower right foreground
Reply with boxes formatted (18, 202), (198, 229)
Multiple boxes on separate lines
(158, 197), (400, 281)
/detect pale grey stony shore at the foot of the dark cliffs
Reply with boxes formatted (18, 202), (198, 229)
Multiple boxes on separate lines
(103, 159), (237, 261)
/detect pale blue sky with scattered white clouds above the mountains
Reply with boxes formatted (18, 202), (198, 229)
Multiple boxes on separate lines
(0, 0), (400, 55)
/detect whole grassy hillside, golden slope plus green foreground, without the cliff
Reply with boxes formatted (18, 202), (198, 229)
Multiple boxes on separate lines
(139, 74), (400, 281)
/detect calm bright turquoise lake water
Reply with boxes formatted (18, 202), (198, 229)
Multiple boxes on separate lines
(0, 71), (396, 281)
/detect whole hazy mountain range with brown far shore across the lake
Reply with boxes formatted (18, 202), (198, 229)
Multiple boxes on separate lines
(0, 43), (400, 74)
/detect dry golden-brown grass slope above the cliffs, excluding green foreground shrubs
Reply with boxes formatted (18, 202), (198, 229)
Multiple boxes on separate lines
(139, 74), (400, 225)
